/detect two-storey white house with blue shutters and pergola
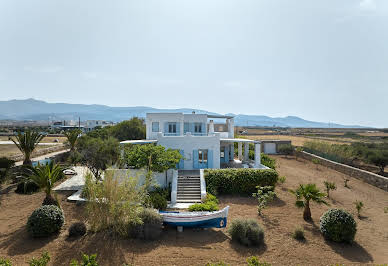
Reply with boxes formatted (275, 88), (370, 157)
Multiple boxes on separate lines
(121, 113), (265, 170)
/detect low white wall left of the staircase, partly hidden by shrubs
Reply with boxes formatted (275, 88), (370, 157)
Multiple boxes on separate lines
(107, 169), (174, 188)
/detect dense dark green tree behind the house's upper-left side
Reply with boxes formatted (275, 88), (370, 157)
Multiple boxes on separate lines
(110, 117), (146, 141)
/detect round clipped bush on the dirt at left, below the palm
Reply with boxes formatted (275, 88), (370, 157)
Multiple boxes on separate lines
(27, 205), (65, 237)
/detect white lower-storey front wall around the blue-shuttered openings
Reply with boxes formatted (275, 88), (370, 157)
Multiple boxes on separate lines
(157, 133), (220, 170)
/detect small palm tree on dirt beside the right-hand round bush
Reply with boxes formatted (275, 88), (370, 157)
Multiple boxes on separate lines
(290, 184), (328, 221)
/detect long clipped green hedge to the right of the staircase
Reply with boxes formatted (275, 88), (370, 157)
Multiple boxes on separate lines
(205, 168), (278, 195)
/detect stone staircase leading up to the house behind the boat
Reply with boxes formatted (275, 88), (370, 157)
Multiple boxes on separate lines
(177, 171), (201, 203)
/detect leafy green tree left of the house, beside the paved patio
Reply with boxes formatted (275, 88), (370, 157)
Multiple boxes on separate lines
(77, 136), (119, 179)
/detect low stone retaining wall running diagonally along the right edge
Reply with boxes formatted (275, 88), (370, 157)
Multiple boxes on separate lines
(300, 151), (388, 191)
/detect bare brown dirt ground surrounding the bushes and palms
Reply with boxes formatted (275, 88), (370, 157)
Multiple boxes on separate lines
(0, 156), (388, 265)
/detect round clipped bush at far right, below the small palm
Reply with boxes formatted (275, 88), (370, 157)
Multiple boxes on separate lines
(320, 209), (357, 243)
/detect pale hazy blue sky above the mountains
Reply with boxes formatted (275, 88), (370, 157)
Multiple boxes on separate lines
(0, 0), (388, 127)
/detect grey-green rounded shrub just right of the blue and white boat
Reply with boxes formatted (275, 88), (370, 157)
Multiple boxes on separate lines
(228, 219), (264, 247)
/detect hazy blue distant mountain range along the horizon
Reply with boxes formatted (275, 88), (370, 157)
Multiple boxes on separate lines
(0, 99), (360, 128)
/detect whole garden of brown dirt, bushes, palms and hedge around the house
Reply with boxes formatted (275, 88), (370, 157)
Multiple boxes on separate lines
(0, 126), (388, 265)
